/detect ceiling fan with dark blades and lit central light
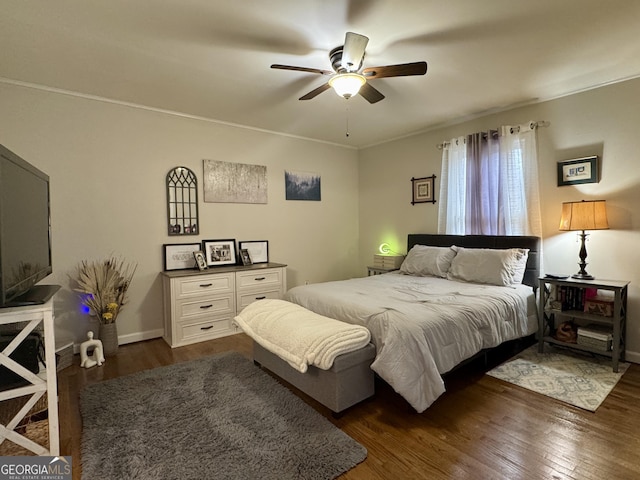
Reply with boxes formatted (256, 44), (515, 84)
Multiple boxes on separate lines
(271, 32), (427, 103)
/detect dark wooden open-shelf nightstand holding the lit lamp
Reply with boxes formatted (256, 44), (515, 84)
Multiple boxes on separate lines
(538, 277), (629, 372)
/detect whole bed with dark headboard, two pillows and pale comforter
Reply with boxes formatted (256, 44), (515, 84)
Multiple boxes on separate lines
(284, 234), (540, 412)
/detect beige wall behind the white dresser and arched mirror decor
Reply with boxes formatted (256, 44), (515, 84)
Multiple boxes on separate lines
(0, 84), (359, 342)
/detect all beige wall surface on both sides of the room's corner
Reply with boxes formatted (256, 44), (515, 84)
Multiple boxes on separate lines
(5, 80), (640, 361)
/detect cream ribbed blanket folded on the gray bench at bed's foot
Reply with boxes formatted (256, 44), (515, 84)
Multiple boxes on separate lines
(234, 299), (371, 373)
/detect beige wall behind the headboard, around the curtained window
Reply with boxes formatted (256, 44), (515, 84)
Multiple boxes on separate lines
(359, 79), (640, 362)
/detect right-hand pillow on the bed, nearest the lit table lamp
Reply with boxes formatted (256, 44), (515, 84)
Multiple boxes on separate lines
(447, 246), (529, 286)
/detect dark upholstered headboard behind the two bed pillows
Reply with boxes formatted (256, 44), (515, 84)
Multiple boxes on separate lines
(407, 233), (542, 288)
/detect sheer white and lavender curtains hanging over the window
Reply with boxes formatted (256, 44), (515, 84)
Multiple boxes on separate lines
(438, 122), (542, 236)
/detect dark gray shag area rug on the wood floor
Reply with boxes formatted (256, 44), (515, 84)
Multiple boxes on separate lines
(80, 352), (367, 480)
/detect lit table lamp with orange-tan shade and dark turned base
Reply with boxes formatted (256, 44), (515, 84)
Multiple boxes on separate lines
(560, 200), (609, 280)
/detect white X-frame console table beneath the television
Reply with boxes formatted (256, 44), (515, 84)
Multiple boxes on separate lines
(0, 299), (60, 456)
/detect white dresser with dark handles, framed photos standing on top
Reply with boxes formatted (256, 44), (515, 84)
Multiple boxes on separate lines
(162, 263), (287, 347)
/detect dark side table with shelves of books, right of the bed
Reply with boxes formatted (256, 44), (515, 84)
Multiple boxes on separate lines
(538, 277), (629, 372)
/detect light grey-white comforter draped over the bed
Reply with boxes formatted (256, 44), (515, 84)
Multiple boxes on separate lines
(285, 273), (537, 412)
